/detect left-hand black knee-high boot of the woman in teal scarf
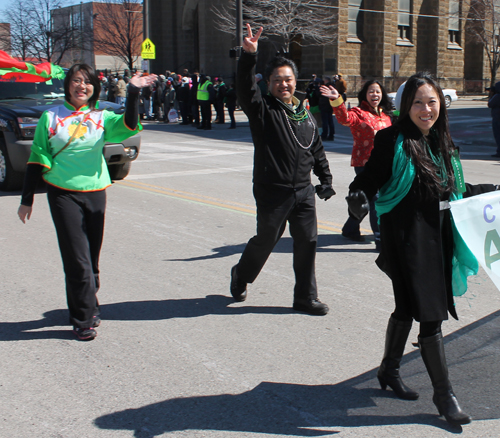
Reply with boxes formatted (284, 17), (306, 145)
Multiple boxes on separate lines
(377, 316), (418, 400)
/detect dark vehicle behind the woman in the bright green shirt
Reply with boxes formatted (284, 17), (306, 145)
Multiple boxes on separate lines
(0, 77), (141, 191)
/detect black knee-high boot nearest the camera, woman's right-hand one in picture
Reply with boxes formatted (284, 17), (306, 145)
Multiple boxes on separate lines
(418, 332), (472, 424)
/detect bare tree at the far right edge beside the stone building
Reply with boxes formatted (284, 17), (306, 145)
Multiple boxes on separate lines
(464, 0), (500, 87)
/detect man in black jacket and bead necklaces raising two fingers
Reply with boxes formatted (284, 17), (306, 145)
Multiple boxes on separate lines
(231, 24), (335, 315)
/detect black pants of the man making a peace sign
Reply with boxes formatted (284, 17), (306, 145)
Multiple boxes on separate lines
(237, 184), (318, 299)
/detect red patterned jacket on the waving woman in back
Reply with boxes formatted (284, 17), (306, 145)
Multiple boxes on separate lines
(331, 101), (391, 167)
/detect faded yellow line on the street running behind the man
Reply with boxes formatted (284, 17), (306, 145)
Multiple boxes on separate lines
(114, 180), (370, 234)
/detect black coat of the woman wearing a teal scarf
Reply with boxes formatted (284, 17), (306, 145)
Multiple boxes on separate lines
(349, 126), (495, 322)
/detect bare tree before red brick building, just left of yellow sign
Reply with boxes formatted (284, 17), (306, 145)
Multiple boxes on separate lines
(94, 0), (142, 69)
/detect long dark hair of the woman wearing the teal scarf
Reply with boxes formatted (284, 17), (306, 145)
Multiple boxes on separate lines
(396, 72), (455, 198)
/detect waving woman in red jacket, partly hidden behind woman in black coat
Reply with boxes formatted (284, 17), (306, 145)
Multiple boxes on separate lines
(320, 80), (391, 249)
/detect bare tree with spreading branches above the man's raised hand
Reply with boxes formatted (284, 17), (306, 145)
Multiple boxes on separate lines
(212, 0), (337, 52)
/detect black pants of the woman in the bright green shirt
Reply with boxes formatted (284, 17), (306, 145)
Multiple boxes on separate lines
(47, 186), (106, 328)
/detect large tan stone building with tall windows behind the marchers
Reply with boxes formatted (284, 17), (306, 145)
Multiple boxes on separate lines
(147, 0), (490, 95)
